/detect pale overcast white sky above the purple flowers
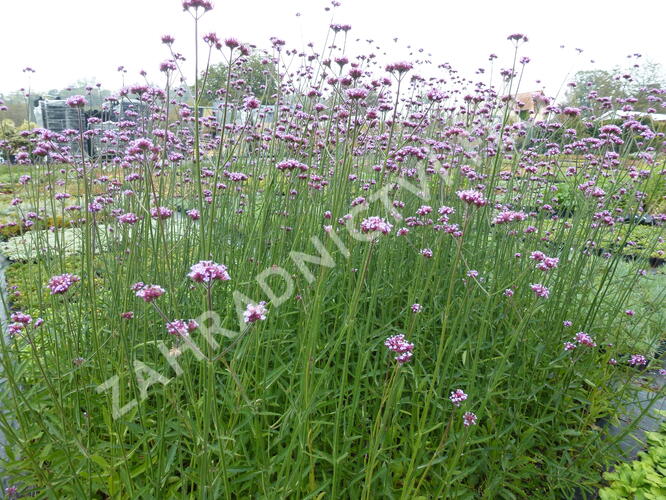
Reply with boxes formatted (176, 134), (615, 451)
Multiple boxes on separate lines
(0, 0), (666, 95)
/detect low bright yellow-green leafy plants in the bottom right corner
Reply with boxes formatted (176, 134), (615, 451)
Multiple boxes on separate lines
(599, 411), (666, 500)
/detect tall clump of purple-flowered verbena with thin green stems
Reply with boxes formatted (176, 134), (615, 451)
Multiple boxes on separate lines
(0, 0), (666, 498)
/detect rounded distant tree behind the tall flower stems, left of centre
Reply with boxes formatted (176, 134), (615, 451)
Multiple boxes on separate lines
(199, 55), (277, 106)
